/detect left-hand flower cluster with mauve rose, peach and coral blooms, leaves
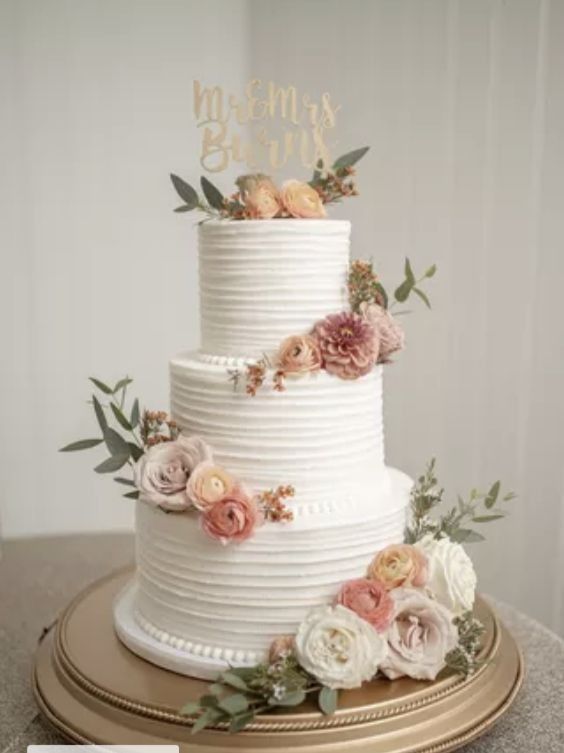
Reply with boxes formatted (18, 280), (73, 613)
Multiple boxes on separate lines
(61, 377), (294, 545)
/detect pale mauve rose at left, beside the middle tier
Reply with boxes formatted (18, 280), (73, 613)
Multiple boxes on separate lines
(133, 435), (212, 510)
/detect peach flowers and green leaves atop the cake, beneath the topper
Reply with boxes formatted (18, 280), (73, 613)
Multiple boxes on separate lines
(170, 146), (369, 221)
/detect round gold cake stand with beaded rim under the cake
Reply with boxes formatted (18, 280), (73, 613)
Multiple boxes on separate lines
(33, 569), (523, 753)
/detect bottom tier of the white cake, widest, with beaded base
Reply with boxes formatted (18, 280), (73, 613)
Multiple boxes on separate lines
(115, 469), (411, 679)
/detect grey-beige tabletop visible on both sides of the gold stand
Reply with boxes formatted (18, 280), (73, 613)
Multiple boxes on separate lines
(0, 534), (564, 753)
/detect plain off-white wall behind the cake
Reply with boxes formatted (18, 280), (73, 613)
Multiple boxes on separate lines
(0, 0), (564, 633)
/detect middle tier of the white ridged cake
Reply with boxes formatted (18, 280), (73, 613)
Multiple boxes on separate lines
(170, 353), (390, 515)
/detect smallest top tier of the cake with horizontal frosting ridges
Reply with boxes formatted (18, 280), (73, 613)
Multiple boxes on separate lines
(199, 219), (350, 357)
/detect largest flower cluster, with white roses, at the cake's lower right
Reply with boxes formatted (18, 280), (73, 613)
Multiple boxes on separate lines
(180, 461), (514, 733)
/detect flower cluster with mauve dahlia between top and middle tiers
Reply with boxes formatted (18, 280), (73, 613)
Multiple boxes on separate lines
(228, 259), (437, 397)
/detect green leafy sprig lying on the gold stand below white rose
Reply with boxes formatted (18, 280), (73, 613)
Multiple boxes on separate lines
(180, 651), (337, 734)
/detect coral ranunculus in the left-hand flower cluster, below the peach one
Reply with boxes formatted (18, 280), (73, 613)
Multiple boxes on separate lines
(201, 486), (262, 544)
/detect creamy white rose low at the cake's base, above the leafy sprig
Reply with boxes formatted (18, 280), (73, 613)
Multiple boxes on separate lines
(295, 604), (388, 689)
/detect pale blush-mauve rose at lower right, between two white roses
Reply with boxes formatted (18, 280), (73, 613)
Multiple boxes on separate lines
(380, 588), (458, 680)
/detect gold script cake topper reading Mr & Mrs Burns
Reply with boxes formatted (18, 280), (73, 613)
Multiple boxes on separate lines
(193, 78), (341, 173)
